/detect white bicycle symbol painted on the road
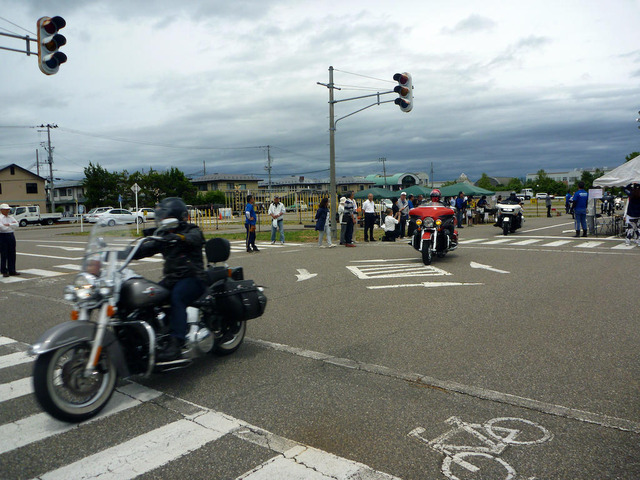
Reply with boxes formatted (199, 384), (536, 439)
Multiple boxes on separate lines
(409, 417), (553, 480)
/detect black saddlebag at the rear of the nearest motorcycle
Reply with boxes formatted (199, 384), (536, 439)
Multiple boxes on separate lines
(212, 279), (267, 321)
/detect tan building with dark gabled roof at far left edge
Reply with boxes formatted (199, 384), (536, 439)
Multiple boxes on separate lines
(0, 163), (47, 211)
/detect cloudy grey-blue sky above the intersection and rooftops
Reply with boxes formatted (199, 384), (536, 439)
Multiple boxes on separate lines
(0, 0), (640, 185)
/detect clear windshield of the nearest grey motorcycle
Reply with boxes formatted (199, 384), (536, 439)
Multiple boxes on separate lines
(82, 220), (140, 277)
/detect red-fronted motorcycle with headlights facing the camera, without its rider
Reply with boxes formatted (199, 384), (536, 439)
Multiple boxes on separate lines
(409, 205), (458, 265)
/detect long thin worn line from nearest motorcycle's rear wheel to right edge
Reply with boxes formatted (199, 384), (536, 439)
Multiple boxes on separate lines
(246, 338), (640, 434)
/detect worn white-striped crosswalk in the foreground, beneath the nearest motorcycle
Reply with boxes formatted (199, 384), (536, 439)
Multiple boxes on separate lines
(0, 336), (399, 480)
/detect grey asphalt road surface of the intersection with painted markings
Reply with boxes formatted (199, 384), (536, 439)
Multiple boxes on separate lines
(0, 216), (640, 479)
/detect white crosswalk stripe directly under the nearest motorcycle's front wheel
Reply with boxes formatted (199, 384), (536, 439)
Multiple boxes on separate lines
(0, 384), (161, 454)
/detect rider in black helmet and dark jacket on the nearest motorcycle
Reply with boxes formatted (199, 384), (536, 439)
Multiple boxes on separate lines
(135, 197), (206, 362)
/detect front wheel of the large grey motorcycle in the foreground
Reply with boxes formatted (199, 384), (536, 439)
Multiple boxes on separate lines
(33, 343), (118, 422)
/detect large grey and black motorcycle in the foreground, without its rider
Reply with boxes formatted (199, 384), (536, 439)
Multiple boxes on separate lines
(29, 218), (267, 422)
